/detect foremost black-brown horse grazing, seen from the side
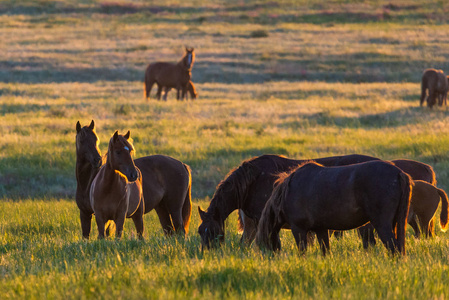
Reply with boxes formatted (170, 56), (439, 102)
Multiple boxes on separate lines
(256, 161), (412, 255)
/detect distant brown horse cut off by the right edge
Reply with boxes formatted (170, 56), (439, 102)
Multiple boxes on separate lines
(419, 69), (449, 108)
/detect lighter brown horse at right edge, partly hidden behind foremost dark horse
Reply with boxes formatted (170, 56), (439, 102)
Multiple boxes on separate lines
(358, 180), (449, 249)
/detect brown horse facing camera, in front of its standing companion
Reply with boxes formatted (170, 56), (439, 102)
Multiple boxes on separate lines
(90, 131), (145, 239)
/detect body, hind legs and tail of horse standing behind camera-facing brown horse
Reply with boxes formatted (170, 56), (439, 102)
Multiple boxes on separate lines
(134, 155), (192, 235)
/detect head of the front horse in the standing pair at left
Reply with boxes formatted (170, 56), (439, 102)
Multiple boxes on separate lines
(107, 131), (139, 182)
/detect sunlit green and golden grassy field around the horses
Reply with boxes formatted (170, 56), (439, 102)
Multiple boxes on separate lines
(0, 0), (449, 299)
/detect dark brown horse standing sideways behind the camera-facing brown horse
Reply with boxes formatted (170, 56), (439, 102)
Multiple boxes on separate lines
(76, 121), (192, 239)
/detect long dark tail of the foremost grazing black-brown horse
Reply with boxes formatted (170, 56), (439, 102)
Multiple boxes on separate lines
(395, 172), (413, 255)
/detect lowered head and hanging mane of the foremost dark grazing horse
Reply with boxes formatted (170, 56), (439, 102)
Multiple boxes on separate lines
(256, 175), (292, 250)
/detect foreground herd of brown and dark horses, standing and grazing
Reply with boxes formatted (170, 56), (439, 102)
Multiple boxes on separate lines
(76, 120), (449, 255)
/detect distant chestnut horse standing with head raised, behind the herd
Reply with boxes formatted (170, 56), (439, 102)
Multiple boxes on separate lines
(145, 47), (195, 101)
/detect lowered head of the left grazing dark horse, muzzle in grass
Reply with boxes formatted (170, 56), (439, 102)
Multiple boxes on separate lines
(198, 206), (224, 249)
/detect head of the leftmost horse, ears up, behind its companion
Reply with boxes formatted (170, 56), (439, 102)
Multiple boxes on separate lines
(76, 120), (102, 168)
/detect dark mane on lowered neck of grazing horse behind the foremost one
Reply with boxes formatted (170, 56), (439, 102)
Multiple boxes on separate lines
(207, 159), (261, 221)
